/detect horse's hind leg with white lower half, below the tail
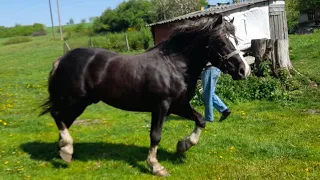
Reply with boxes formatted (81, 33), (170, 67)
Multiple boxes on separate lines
(51, 103), (88, 162)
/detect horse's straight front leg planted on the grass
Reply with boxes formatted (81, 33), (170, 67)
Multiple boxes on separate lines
(147, 101), (170, 176)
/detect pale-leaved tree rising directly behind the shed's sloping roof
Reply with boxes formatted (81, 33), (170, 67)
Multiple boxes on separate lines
(151, 0), (208, 21)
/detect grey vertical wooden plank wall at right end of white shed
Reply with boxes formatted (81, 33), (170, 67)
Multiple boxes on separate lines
(269, 4), (288, 39)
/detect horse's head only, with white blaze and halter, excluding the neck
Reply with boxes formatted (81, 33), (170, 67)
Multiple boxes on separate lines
(207, 14), (250, 80)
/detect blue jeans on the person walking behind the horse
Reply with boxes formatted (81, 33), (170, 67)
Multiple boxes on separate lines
(201, 66), (228, 121)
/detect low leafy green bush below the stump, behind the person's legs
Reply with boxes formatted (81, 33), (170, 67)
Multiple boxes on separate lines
(191, 70), (309, 105)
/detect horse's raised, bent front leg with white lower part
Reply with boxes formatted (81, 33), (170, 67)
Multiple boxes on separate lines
(172, 103), (206, 154)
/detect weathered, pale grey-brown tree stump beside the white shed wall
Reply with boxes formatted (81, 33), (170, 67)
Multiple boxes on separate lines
(251, 39), (293, 77)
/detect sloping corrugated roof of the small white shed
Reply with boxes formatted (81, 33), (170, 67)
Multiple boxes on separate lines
(147, 0), (269, 27)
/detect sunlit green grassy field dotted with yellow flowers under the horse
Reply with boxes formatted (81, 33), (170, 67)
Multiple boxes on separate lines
(0, 34), (320, 180)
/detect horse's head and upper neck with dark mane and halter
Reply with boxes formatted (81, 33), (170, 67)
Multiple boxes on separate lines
(163, 14), (250, 79)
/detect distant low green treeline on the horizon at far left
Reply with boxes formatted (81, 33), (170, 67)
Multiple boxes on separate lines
(0, 23), (46, 38)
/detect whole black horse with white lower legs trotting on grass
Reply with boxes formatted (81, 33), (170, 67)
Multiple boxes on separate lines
(42, 14), (250, 176)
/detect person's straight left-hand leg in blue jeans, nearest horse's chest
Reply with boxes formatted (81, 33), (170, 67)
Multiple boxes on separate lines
(201, 68), (213, 121)
